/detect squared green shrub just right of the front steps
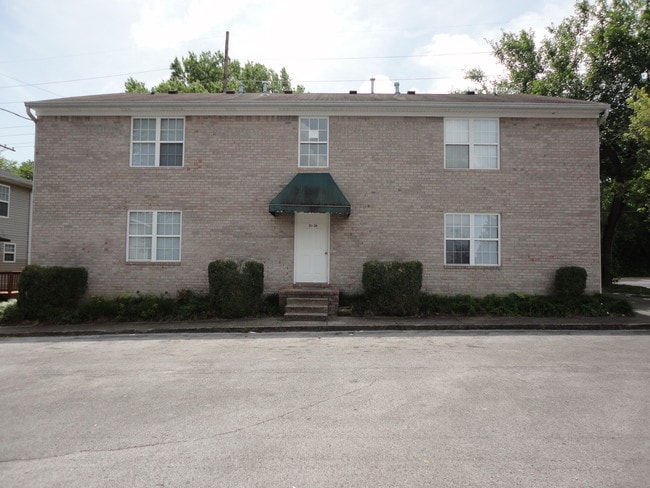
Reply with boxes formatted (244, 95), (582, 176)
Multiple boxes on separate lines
(361, 261), (422, 316)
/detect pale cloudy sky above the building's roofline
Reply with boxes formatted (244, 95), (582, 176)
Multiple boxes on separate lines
(0, 0), (575, 162)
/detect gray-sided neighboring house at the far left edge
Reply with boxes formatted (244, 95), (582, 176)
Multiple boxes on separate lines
(0, 170), (32, 272)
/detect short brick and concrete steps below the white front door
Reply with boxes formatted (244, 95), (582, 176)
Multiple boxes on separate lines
(279, 284), (339, 322)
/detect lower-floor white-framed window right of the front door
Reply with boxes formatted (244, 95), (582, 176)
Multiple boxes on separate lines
(445, 214), (501, 266)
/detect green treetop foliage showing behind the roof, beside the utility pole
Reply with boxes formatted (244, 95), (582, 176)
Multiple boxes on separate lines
(124, 51), (305, 93)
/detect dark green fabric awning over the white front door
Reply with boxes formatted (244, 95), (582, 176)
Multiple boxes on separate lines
(269, 173), (350, 216)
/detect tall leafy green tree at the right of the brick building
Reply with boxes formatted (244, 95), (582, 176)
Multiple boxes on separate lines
(468, 0), (650, 284)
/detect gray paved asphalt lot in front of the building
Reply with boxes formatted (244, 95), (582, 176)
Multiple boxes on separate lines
(0, 332), (650, 488)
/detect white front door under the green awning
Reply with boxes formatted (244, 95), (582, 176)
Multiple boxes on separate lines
(294, 213), (330, 283)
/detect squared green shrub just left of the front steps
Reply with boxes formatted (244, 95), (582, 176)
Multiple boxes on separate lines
(208, 260), (264, 318)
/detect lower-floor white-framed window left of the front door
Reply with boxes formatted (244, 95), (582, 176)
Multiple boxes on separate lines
(127, 211), (181, 262)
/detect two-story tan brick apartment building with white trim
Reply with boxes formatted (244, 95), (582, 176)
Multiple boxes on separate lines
(26, 93), (607, 295)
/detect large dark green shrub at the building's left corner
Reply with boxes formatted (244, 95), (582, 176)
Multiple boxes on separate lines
(18, 265), (88, 320)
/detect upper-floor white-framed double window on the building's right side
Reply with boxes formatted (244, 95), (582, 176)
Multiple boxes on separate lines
(445, 119), (499, 169)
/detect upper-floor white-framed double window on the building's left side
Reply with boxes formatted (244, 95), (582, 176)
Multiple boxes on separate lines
(131, 118), (185, 166)
